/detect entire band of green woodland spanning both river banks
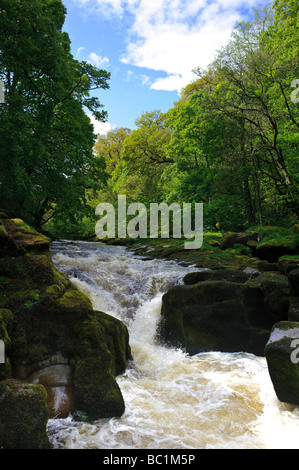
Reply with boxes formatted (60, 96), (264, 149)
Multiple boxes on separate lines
(0, 0), (299, 236)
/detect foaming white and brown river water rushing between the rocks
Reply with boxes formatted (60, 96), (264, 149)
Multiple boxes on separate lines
(48, 241), (299, 449)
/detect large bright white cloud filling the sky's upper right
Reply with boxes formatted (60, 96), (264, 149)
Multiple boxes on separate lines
(73, 0), (269, 91)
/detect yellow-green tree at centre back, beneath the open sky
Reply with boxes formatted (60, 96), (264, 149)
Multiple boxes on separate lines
(95, 111), (172, 203)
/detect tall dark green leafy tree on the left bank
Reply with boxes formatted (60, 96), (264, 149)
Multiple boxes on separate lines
(0, 0), (110, 228)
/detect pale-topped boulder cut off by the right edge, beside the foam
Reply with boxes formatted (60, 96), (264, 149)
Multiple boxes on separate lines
(265, 321), (299, 405)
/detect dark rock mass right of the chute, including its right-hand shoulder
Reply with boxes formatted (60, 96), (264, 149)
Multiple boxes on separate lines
(160, 268), (290, 356)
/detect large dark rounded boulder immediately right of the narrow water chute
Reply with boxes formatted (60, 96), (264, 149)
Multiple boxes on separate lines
(160, 280), (273, 355)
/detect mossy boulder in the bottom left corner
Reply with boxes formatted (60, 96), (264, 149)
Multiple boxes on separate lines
(0, 379), (50, 449)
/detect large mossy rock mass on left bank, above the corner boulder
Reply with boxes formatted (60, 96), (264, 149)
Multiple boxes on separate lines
(0, 217), (130, 428)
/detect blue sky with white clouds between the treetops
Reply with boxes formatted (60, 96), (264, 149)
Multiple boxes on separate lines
(63, 0), (270, 134)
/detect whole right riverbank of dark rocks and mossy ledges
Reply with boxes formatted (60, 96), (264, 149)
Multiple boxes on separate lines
(102, 224), (299, 405)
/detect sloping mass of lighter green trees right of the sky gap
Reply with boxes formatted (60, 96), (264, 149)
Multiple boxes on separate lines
(94, 0), (299, 230)
